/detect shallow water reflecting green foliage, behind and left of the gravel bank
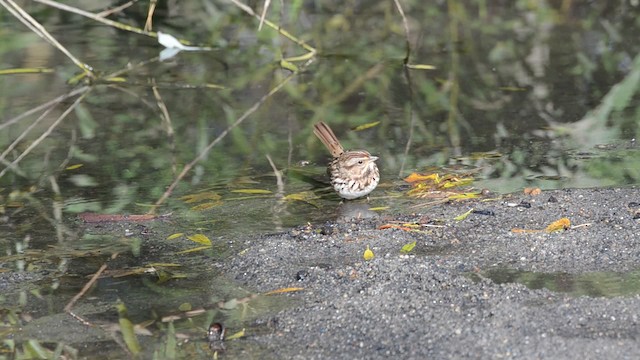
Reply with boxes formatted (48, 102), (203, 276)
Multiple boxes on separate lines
(0, 1), (640, 358)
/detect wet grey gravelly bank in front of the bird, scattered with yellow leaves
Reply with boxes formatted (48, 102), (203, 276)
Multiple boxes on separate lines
(223, 188), (640, 359)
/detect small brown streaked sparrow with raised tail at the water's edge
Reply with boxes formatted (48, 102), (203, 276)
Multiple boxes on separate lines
(313, 122), (380, 200)
